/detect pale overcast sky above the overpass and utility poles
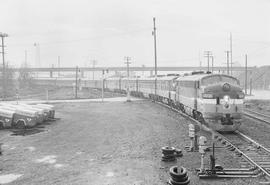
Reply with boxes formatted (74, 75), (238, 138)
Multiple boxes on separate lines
(0, 0), (270, 67)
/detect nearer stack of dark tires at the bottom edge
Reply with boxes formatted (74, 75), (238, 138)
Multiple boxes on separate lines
(169, 166), (190, 185)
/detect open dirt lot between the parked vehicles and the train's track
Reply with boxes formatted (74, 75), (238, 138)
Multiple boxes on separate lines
(0, 100), (258, 185)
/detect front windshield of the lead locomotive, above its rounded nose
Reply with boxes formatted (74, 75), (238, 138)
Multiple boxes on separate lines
(202, 75), (239, 86)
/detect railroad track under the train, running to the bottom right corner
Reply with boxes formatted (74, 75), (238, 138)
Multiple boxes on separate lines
(156, 102), (270, 183)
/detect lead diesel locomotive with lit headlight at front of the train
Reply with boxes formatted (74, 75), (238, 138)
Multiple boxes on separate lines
(175, 74), (244, 131)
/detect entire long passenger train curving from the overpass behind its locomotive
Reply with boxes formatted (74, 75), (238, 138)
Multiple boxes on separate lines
(32, 71), (245, 132)
